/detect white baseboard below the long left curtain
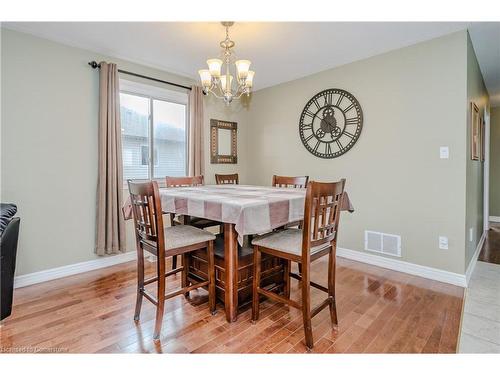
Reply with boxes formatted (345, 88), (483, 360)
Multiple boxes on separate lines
(14, 251), (136, 288)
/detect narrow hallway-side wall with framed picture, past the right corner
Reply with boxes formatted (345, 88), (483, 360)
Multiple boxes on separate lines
(464, 34), (488, 267)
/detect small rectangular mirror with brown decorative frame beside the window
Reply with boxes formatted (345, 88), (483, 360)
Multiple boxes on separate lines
(210, 119), (238, 164)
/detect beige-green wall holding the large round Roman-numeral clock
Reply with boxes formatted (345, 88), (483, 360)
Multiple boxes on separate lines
(248, 31), (467, 273)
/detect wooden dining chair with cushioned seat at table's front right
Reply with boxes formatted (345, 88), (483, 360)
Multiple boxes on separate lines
(252, 179), (345, 349)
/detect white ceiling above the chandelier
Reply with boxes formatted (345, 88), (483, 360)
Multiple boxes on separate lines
(2, 22), (500, 104)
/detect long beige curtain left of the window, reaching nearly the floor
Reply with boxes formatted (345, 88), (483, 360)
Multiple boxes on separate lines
(95, 62), (125, 255)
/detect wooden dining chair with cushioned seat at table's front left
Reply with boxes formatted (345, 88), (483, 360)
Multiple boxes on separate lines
(128, 180), (216, 340)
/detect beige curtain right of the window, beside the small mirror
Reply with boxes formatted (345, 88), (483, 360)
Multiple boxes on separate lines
(189, 86), (204, 176)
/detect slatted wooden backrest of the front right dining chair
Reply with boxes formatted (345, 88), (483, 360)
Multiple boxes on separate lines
(302, 179), (345, 257)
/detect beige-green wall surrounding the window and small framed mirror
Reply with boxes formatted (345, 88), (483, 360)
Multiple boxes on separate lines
(1, 29), (245, 275)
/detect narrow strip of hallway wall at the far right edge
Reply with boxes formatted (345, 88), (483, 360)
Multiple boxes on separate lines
(490, 107), (500, 217)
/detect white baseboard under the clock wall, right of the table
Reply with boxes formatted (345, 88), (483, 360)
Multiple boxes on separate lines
(337, 248), (467, 288)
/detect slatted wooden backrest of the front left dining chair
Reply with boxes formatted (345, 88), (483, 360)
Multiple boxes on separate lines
(127, 180), (165, 257)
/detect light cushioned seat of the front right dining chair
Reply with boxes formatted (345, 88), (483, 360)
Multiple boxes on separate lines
(252, 228), (330, 256)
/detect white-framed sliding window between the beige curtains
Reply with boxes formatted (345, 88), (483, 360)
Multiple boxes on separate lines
(120, 80), (188, 184)
